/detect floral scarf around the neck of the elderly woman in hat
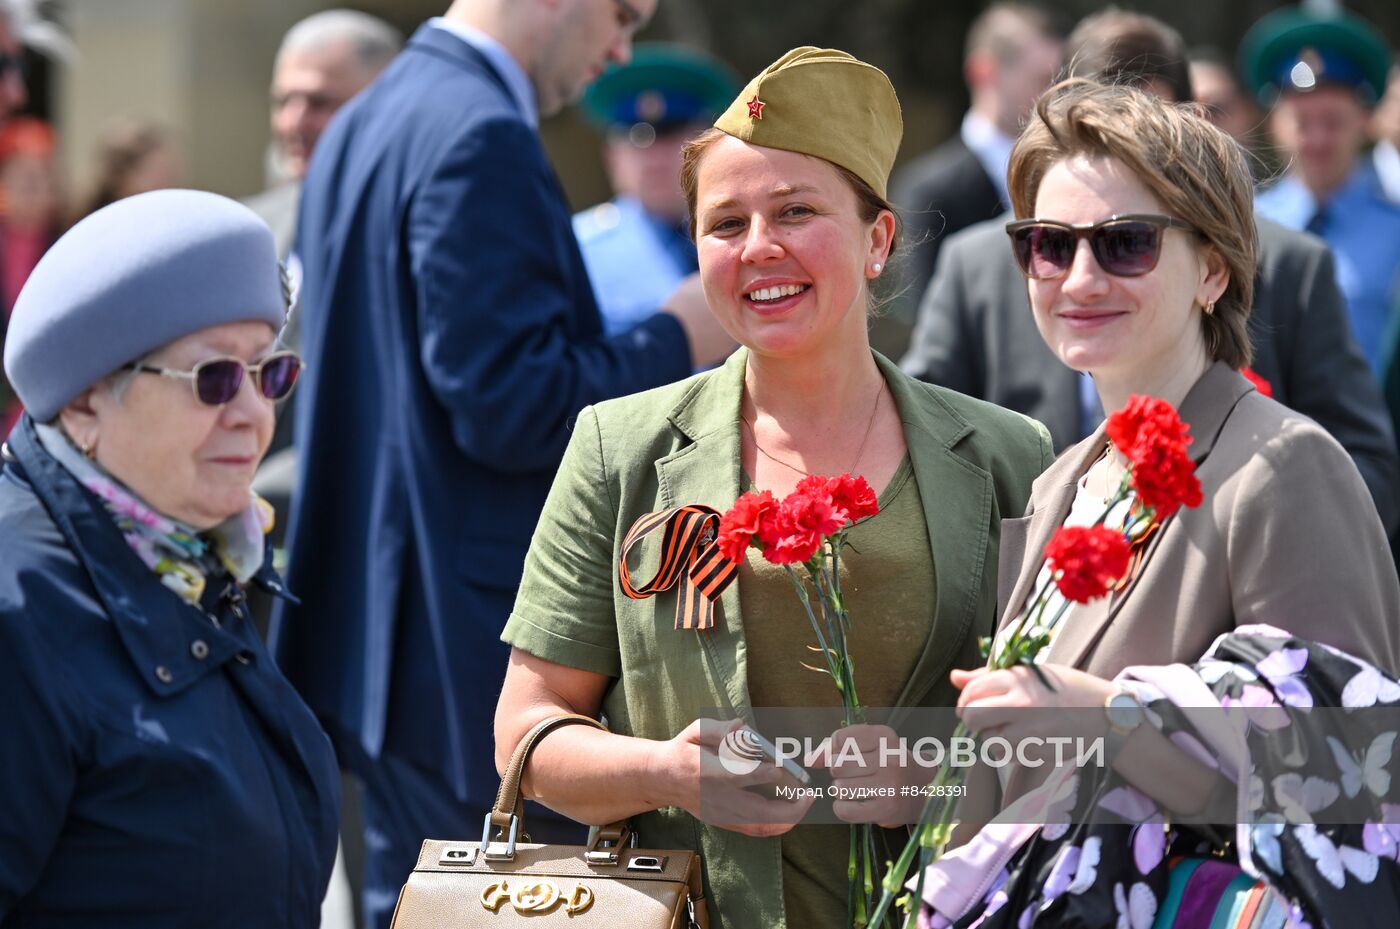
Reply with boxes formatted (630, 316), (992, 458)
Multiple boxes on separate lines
(35, 424), (274, 604)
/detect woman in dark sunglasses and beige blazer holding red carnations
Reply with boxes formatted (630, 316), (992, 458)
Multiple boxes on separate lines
(924, 81), (1400, 929)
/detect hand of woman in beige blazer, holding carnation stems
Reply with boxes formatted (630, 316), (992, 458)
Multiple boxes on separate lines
(952, 665), (1117, 744)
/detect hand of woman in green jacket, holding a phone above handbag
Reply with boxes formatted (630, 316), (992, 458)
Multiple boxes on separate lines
(651, 719), (815, 838)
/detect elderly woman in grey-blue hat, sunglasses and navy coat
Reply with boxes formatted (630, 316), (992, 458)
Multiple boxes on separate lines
(0, 190), (339, 929)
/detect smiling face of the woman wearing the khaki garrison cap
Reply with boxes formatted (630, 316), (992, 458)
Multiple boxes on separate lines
(696, 136), (895, 357)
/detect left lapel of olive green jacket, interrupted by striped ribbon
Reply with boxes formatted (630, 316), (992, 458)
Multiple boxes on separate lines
(657, 348), (750, 718)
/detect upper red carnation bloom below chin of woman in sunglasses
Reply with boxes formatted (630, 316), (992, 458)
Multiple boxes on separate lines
(1106, 396), (1201, 520)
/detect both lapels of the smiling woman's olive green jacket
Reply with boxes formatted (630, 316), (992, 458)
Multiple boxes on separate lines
(657, 348), (994, 715)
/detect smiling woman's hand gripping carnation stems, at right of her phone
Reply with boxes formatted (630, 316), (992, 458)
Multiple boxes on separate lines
(827, 725), (937, 828)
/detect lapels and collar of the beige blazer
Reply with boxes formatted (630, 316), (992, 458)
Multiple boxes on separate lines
(1002, 361), (1254, 667)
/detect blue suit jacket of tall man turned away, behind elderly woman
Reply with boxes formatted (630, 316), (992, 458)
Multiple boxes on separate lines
(272, 27), (690, 799)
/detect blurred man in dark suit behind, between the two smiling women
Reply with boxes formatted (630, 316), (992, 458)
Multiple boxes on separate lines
(890, 3), (1060, 311)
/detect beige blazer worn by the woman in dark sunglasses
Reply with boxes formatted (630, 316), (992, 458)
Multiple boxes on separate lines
(997, 362), (1400, 677)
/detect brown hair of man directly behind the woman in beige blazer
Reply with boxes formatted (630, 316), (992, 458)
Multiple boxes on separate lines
(1065, 7), (1191, 104)
